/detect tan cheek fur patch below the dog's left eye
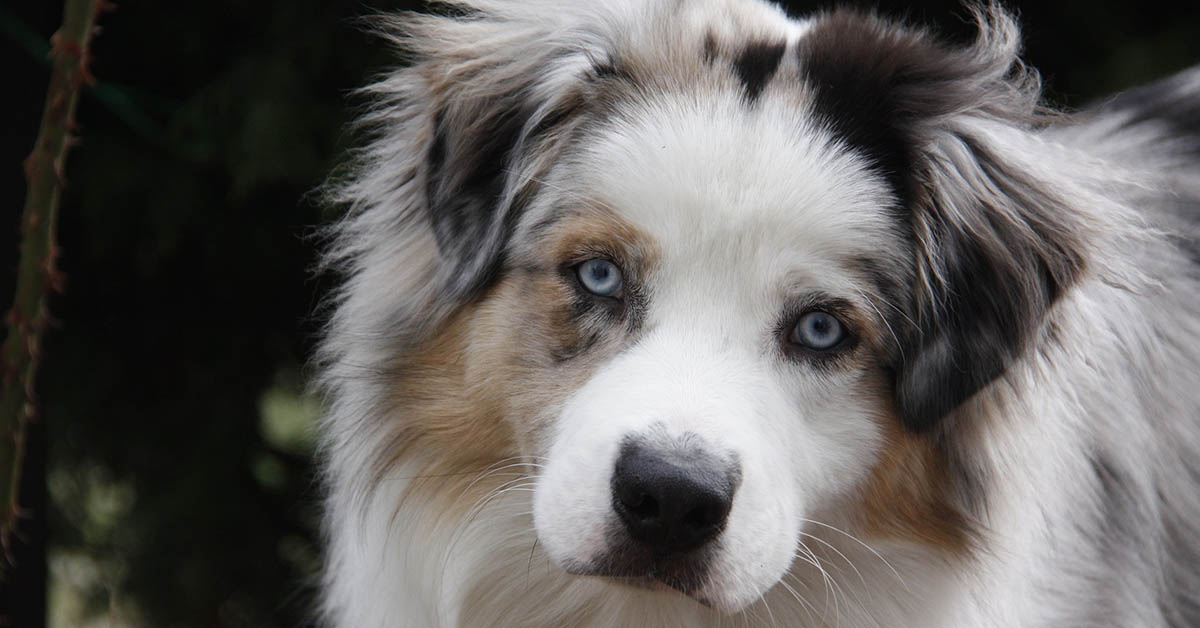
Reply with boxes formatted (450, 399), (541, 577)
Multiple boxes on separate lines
(383, 273), (587, 472)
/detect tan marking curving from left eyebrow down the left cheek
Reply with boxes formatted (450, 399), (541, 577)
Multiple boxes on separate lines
(376, 210), (656, 514)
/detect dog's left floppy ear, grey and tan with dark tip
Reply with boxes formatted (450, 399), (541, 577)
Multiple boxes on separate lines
(412, 14), (597, 300)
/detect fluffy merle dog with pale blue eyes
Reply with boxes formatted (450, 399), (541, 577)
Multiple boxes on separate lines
(317, 0), (1200, 628)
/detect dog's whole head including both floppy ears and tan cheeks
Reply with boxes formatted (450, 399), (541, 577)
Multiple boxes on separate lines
(336, 0), (1082, 610)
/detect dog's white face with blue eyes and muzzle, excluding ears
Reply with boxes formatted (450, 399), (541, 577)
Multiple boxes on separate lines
(512, 92), (905, 609)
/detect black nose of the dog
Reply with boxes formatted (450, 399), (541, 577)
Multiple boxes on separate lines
(612, 443), (740, 554)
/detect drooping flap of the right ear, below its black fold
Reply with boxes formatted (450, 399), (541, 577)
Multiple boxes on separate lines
(894, 134), (1084, 431)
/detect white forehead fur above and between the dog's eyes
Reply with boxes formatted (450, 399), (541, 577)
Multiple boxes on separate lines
(570, 92), (901, 309)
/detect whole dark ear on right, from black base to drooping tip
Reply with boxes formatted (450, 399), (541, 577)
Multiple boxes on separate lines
(802, 7), (1084, 431)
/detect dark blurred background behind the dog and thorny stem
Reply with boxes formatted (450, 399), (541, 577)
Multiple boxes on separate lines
(0, 0), (1200, 627)
